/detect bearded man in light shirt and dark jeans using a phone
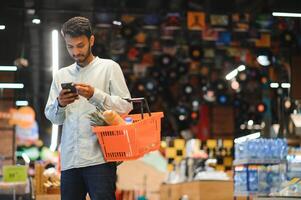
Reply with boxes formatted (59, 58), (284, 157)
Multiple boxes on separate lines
(45, 17), (132, 200)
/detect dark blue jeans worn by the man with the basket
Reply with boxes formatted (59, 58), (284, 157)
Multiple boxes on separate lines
(61, 162), (116, 200)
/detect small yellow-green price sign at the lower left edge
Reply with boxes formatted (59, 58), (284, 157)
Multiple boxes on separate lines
(3, 165), (27, 182)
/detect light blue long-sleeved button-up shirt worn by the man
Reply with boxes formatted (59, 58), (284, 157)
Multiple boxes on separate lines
(45, 57), (132, 170)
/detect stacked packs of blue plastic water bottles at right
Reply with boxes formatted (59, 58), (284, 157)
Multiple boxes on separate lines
(233, 138), (288, 196)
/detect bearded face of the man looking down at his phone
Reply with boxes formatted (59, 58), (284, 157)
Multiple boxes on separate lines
(65, 35), (94, 64)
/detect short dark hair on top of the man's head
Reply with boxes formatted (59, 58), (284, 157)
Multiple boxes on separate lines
(61, 17), (93, 38)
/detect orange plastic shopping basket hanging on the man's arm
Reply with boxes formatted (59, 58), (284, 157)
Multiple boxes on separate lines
(92, 98), (163, 162)
